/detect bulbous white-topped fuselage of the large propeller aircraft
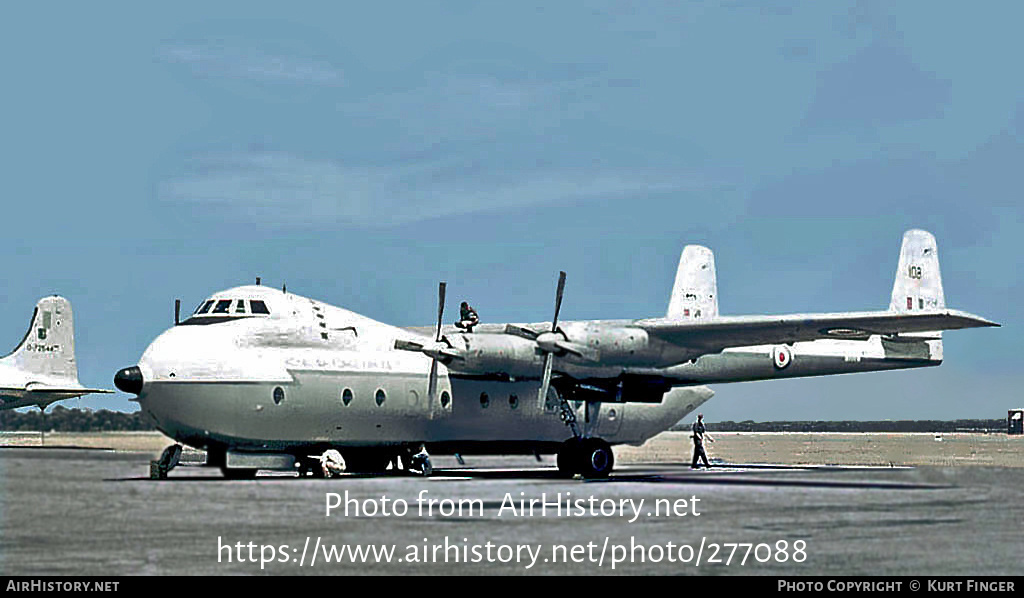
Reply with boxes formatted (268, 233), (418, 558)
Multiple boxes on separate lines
(132, 287), (713, 454)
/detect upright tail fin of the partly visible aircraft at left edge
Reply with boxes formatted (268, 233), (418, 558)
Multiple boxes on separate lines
(2, 295), (78, 384)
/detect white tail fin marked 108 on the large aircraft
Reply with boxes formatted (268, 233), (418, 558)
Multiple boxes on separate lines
(889, 229), (946, 313)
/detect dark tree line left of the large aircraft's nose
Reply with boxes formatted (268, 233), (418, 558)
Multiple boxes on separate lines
(0, 405), (156, 432)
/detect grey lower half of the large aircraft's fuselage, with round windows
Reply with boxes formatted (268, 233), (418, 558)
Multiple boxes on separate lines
(139, 371), (674, 450)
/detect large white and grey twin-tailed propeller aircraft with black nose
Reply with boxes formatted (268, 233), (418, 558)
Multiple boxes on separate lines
(115, 230), (997, 477)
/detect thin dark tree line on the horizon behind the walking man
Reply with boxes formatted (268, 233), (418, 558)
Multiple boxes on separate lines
(672, 420), (1007, 433)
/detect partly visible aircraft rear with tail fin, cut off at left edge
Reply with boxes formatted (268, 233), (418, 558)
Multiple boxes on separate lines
(0, 295), (114, 410)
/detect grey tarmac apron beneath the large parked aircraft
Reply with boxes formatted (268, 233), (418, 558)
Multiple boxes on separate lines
(0, 447), (1024, 575)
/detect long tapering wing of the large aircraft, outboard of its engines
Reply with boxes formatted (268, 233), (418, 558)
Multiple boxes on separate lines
(633, 309), (999, 353)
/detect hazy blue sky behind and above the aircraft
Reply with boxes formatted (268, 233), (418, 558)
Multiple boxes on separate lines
(0, 0), (1024, 420)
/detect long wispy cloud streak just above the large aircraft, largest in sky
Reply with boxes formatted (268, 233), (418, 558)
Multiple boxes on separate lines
(160, 151), (697, 226)
